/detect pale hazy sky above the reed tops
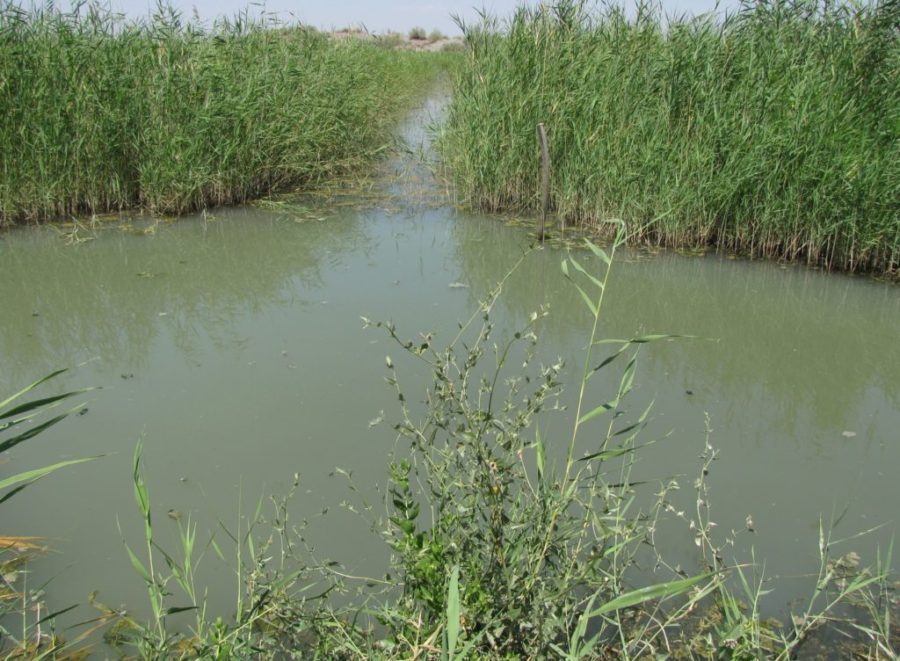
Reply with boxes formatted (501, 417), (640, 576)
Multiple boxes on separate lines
(68, 0), (738, 34)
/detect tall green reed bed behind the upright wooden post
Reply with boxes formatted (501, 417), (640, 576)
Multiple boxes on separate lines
(443, 0), (900, 277)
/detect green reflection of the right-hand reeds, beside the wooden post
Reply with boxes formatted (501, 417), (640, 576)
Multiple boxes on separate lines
(453, 220), (900, 442)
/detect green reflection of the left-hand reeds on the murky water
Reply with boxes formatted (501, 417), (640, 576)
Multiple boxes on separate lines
(0, 208), (368, 383)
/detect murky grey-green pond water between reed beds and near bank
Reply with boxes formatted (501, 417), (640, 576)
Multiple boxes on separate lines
(0, 96), (900, 620)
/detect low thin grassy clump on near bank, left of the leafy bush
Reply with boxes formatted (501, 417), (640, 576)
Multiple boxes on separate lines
(106, 442), (336, 659)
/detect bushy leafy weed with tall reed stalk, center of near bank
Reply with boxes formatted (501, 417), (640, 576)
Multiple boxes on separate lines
(356, 224), (721, 658)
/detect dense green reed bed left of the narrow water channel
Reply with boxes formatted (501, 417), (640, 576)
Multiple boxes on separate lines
(0, 1), (447, 226)
